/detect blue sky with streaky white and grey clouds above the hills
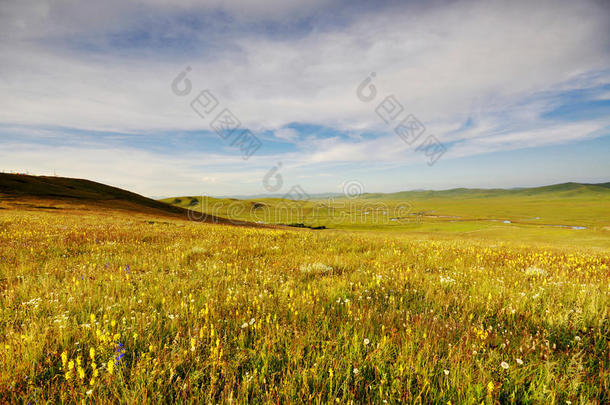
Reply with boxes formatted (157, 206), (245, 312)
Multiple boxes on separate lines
(0, 0), (610, 197)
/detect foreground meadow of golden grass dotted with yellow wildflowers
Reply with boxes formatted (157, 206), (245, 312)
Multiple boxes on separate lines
(0, 202), (610, 404)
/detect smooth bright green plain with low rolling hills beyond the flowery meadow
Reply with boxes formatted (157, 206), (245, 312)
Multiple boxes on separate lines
(162, 183), (610, 249)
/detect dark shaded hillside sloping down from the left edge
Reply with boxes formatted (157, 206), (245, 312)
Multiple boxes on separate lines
(0, 173), (254, 225)
